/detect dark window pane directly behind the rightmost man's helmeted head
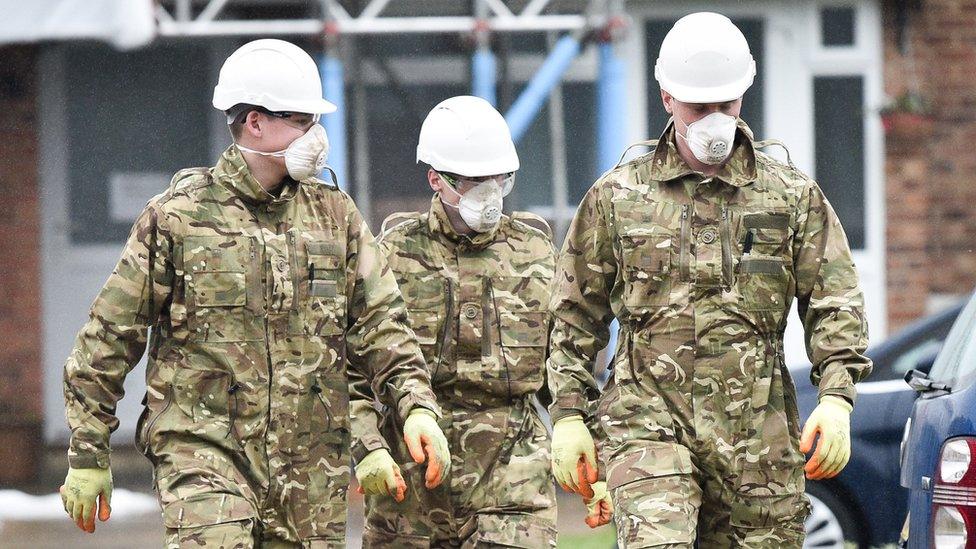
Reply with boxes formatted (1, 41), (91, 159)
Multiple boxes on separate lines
(644, 19), (765, 139)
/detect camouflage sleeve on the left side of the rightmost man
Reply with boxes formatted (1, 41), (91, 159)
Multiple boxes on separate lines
(546, 183), (617, 422)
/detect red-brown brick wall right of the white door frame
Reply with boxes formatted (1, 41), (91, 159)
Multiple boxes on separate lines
(883, 0), (976, 330)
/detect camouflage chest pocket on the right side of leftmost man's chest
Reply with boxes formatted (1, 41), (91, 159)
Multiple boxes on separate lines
(303, 232), (346, 336)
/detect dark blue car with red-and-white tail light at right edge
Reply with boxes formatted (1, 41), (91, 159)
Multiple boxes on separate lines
(901, 293), (976, 549)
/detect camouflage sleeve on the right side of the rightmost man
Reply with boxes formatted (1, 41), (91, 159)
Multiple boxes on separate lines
(793, 182), (871, 404)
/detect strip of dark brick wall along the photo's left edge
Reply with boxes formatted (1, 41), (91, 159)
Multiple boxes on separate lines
(0, 47), (43, 487)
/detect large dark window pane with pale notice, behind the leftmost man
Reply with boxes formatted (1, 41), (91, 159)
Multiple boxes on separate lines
(64, 44), (210, 244)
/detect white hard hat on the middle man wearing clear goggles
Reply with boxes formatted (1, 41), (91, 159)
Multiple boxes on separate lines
(417, 95), (519, 177)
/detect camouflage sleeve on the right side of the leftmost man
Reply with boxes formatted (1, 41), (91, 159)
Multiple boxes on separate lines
(346, 198), (441, 420)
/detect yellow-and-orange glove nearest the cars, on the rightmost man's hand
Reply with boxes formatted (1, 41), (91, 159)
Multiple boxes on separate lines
(800, 395), (854, 480)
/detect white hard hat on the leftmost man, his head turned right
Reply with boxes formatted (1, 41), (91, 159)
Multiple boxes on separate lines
(213, 38), (336, 114)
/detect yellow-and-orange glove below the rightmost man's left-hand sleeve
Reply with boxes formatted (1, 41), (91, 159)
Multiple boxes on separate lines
(552, 416), (597, 498)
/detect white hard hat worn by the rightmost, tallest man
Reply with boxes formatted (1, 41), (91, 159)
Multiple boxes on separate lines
(654, 12), (756, 103)
